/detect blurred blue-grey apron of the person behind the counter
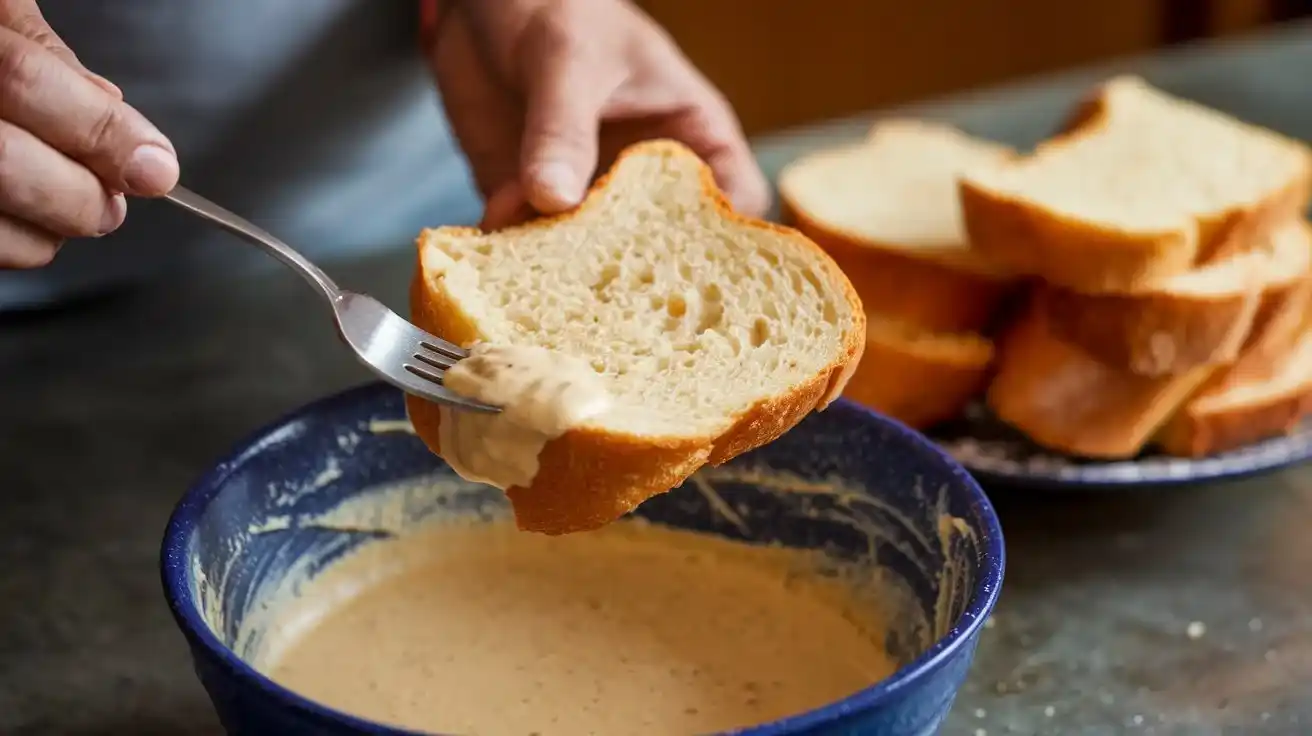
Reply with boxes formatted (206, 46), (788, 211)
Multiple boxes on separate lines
(0, 0), (480, 310)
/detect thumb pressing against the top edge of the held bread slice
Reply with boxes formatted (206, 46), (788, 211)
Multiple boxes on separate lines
(521, 47), (618, 214)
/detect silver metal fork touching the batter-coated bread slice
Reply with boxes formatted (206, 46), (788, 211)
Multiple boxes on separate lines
(165, 186), (501, 412)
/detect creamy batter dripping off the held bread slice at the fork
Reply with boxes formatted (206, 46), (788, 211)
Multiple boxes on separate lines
(438, 342), (611, 491)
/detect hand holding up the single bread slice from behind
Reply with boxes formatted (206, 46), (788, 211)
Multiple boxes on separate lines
(428, 0), (770, 228)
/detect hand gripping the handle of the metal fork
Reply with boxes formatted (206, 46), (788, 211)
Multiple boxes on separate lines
(0, 0), (178, 268)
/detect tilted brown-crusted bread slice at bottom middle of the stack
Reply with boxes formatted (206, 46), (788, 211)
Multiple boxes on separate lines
(988, 293), (1216, 459)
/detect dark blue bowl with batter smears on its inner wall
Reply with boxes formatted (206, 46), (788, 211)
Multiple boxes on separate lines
(161, 384), (1004, 736)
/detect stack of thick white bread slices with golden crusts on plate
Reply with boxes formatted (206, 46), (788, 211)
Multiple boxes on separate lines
(779, 76), (1312, 459)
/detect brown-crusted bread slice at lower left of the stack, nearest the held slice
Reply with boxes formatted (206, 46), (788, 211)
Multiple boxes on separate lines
(842, 315), (993, 429)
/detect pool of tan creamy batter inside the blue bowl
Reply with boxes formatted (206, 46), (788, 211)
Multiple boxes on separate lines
(256, 522), (895, 736)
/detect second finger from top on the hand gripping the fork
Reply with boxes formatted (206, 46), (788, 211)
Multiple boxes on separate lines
(0, 121), (127, 237)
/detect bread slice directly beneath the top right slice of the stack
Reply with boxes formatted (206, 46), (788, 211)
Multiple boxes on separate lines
(1048, 220), (1312, 377)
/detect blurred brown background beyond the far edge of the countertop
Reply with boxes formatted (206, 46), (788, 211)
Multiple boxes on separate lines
(638, 0), (1312, 134)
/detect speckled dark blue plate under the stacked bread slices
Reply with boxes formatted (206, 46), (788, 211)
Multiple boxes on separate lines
(929, 405), (1312, 491)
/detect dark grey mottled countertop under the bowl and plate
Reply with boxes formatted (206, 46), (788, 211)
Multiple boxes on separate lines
(0, 20), (1312, 736)
